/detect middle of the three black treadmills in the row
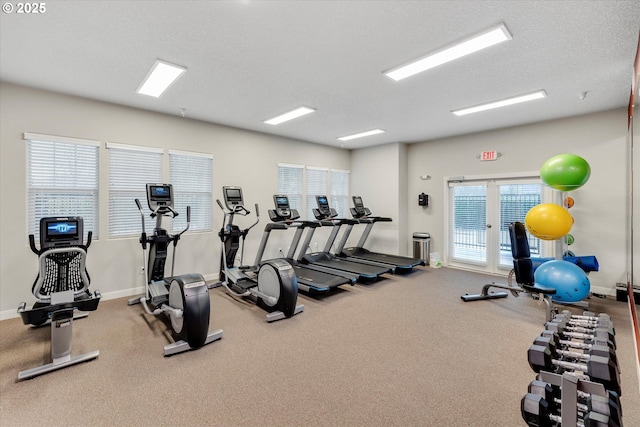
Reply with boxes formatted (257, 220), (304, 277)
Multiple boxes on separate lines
(297, 196), (394, 282)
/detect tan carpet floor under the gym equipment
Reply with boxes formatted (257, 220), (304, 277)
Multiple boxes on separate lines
(0, 267), (640, 427)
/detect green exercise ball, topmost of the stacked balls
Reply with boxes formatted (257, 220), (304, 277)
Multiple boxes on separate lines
(540, 154), (591, 191)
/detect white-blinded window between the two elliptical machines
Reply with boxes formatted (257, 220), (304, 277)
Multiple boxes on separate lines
(169, 150), (213, 233)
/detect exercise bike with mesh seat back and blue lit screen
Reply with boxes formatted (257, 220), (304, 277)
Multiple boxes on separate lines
(18, 217), (100, 380)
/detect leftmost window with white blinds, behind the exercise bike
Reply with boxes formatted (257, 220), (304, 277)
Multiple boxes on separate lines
(24, 133), (100, 240)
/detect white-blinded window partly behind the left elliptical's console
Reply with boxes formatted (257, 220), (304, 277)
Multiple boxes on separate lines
(107, 143), (163, 238)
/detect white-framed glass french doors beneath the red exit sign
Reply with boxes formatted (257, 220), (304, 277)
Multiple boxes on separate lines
(446, 178), (550, 273)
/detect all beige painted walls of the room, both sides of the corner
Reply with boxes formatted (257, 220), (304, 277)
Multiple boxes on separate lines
(0, 83), (640, 319)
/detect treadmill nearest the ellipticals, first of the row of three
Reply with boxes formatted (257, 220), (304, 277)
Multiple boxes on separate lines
(269, 194), (358, 293)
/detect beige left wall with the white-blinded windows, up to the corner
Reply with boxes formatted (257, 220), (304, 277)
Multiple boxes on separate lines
(0, 83), (350, 318)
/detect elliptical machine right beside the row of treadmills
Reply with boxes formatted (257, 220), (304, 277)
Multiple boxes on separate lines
(216, 187), (304, 322)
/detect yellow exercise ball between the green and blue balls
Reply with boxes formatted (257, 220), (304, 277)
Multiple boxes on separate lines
(524, 203), (573, 240)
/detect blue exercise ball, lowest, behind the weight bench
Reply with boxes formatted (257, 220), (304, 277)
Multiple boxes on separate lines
(533, 260), (591, 302)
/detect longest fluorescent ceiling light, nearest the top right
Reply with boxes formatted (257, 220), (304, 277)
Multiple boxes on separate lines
(385, 24), (511, 81)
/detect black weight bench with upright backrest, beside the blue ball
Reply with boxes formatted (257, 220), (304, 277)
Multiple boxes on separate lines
(460, 222), (556, 322)
